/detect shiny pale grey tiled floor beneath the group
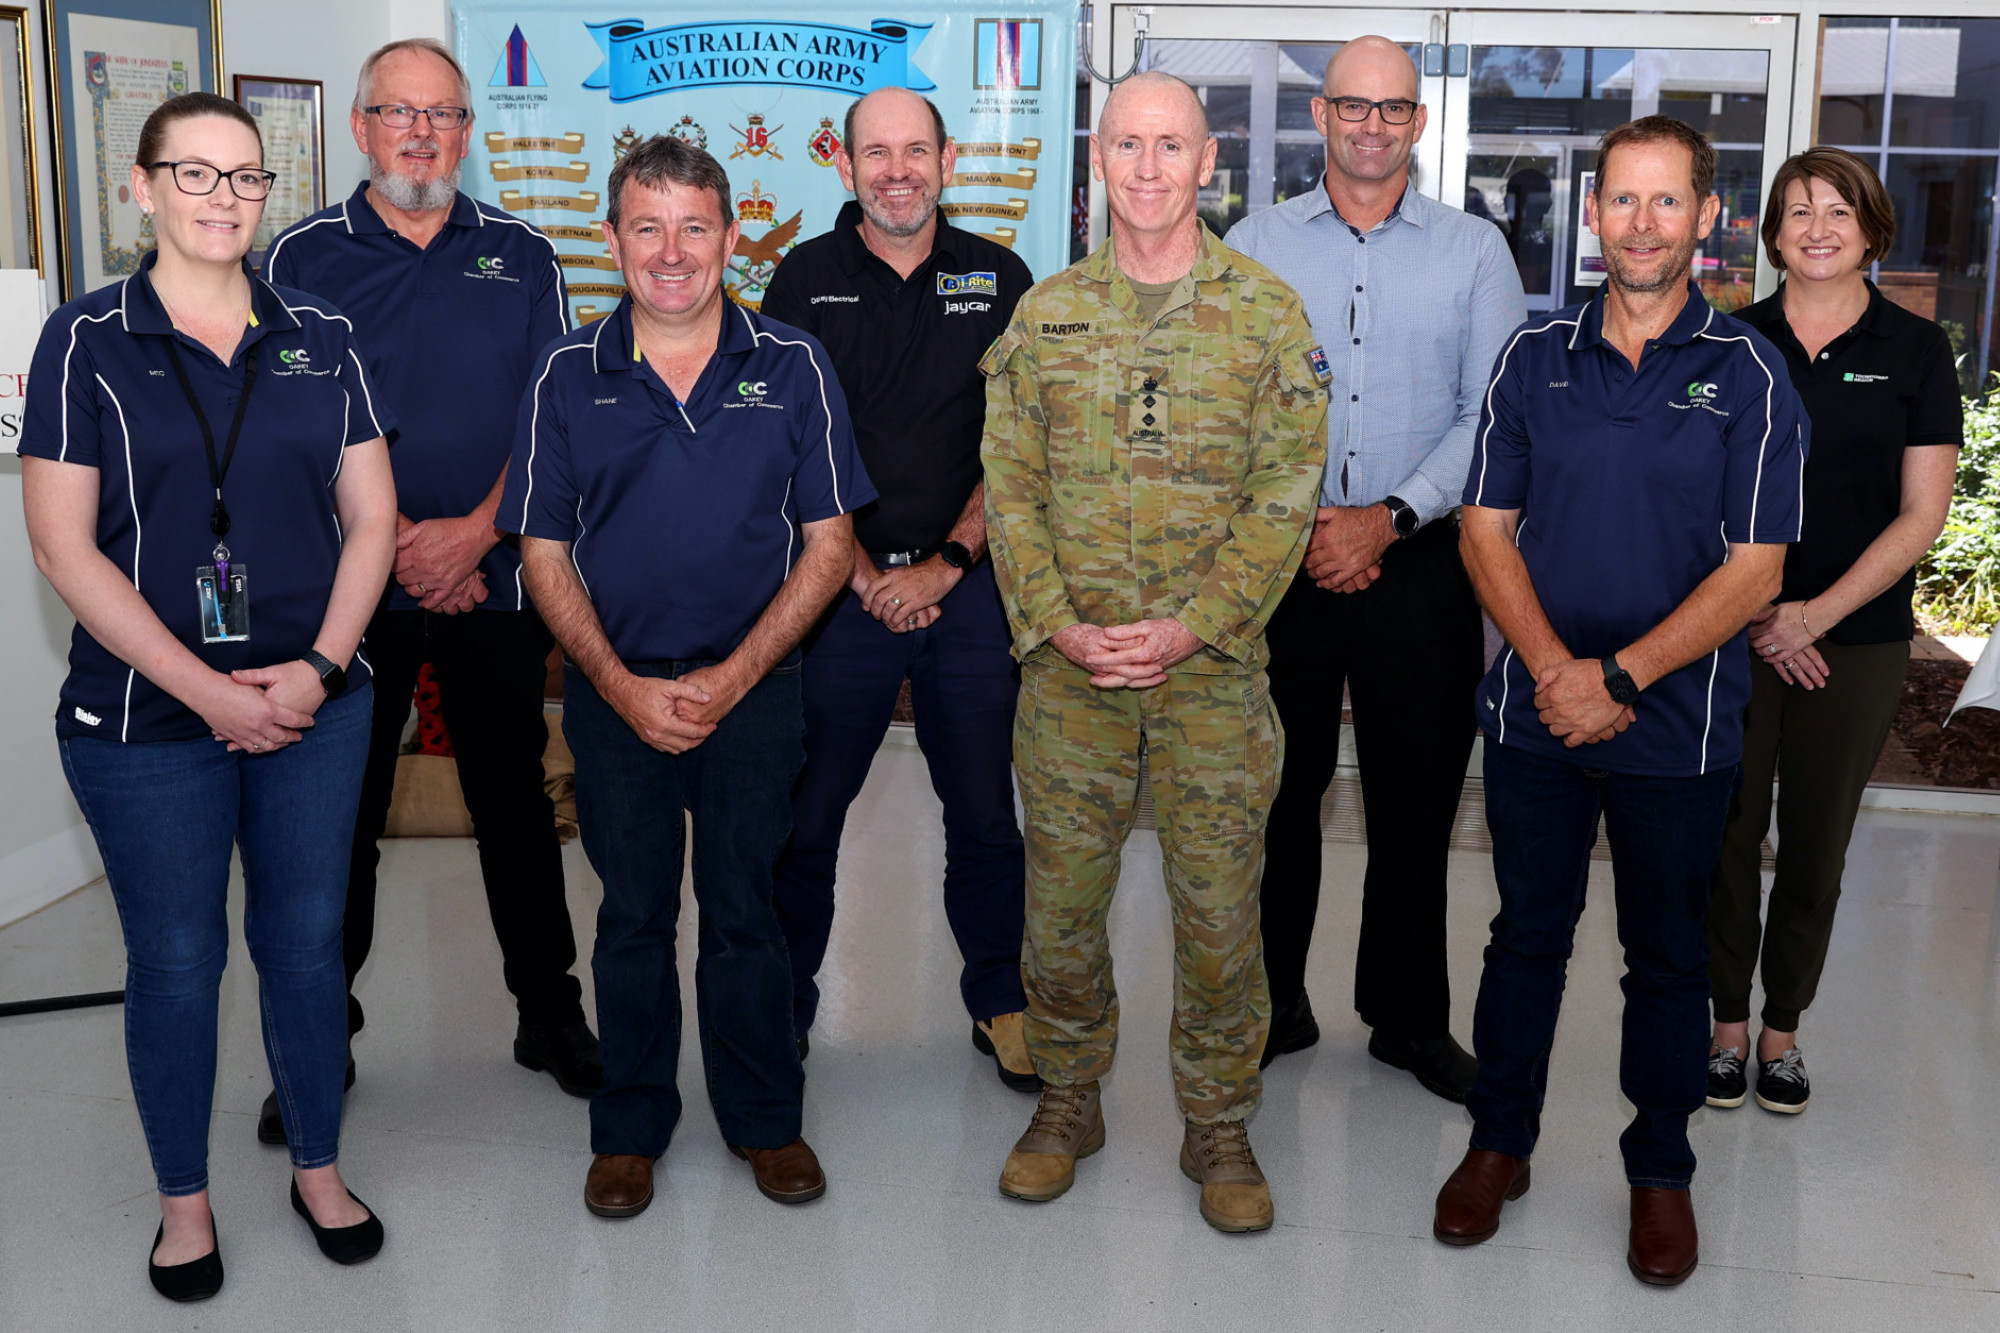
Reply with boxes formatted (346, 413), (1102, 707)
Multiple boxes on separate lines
(0, 747), (2000, 1333)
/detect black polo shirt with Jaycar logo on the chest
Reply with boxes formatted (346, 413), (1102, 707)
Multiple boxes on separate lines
(762, 200), (1034, 550)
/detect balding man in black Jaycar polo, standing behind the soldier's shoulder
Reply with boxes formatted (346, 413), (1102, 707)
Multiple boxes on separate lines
(762, 88), (1038, 1091)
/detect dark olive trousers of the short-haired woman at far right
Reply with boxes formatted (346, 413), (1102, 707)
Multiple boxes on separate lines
(1708, 642), (1910, 1033)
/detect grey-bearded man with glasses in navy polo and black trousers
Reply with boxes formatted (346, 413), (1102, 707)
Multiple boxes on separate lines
(258, 38), (602, 1143)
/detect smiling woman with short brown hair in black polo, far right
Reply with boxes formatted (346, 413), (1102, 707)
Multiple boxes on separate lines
(1708, 148), (1962, 1115)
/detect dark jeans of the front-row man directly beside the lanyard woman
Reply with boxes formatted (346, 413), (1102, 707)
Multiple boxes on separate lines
(562, 652), (806, 1157)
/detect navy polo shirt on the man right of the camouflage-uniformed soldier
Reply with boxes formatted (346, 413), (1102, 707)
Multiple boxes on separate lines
(1464, 282), (1810, 777)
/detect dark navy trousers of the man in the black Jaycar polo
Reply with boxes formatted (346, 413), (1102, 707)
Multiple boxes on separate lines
(776, 560), (1028, 1033)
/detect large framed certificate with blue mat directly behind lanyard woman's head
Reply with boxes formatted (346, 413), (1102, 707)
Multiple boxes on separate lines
(42, 0), (222, 300)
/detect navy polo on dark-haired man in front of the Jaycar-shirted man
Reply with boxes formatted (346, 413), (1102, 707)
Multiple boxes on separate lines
(498, 296), (876, 662)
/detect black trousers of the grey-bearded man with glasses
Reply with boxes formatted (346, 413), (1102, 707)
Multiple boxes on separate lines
(346, 602), (584, 1033)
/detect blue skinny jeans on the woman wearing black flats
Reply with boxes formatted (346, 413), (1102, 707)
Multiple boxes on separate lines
(58, 685), (374, 1195)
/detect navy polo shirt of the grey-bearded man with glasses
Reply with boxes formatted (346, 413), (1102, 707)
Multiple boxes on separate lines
(264, 182), (570, 610)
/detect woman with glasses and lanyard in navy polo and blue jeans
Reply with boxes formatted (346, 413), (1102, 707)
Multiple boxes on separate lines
(20, 92), (396, 1301)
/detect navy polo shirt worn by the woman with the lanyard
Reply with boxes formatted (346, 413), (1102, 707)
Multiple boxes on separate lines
(20, 254), (396, 741)
